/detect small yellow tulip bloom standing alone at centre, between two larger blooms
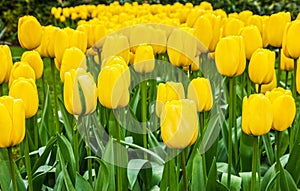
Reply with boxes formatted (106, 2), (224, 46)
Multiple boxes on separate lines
(133, 44), (155, 73)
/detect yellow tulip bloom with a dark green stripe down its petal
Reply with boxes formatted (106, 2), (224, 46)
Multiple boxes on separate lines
(64, 68), (97, 115)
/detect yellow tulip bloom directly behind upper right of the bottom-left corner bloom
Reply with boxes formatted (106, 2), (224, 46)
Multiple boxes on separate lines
(9, 77), (39, 118)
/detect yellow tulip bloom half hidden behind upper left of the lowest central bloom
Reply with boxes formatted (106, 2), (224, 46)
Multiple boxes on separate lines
(156, 82), (185, 117)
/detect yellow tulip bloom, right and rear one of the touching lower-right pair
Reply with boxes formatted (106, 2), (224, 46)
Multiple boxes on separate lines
(266, 88), (296, 131)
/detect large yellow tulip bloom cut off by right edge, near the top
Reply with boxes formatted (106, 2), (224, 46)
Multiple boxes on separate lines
(282, 20), (300, 59)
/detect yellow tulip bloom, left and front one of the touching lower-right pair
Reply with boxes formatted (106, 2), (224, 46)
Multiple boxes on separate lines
(242, 94), (273, 136)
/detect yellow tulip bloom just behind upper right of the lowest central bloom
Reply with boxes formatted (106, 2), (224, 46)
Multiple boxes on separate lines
(188, 78), (213, 112)
